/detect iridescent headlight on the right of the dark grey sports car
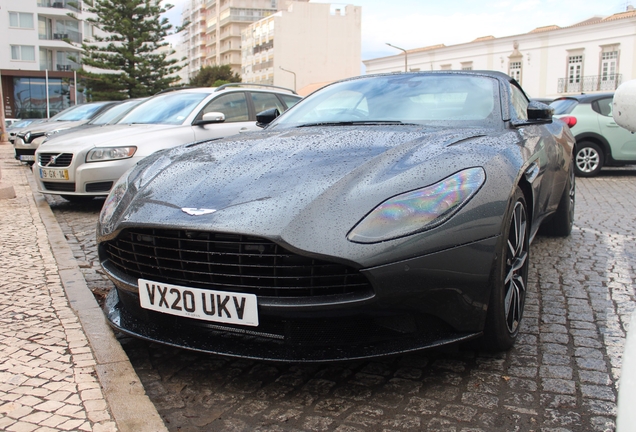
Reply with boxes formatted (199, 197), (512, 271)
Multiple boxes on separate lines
(347, 168), (486, 243)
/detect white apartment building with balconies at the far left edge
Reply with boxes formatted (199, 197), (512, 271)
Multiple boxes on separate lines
(0, 0), (93, 118)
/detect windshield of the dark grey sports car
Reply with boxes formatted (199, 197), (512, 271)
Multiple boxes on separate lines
(272, 74), (501, 127)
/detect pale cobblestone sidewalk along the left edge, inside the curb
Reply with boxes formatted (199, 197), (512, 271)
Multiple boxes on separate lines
(0, 151), (116, 432)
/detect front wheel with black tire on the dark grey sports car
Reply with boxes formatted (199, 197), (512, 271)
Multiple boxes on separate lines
(482, 187), (530, 351)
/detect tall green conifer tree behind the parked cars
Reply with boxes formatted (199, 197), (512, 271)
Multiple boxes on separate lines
(80, 0), (187, 100)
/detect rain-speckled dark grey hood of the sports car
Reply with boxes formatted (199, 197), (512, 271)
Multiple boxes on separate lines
(103, 126), (513, 261)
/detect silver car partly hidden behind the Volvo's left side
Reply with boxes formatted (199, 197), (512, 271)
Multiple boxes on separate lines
(13, 101), (119, 165)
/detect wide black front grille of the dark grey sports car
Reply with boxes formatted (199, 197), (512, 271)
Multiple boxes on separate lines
(103, 229), (371, 297)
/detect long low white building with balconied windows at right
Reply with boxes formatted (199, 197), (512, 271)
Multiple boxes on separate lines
(363, 6), (636, 98)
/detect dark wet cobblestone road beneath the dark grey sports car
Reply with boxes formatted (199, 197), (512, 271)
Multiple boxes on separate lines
(44, 168), (636, 432)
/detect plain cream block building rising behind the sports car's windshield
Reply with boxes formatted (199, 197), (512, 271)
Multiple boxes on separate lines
(241, 2), (362, 94)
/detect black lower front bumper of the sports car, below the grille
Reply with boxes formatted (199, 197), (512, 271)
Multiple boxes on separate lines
(102, 238), (499, 362)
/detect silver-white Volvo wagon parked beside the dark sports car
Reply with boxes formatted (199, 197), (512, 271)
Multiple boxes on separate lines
(33, 84), (301, 201)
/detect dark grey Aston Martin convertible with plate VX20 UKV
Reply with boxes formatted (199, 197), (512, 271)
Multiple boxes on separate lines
(97, 71), (575, 362)
